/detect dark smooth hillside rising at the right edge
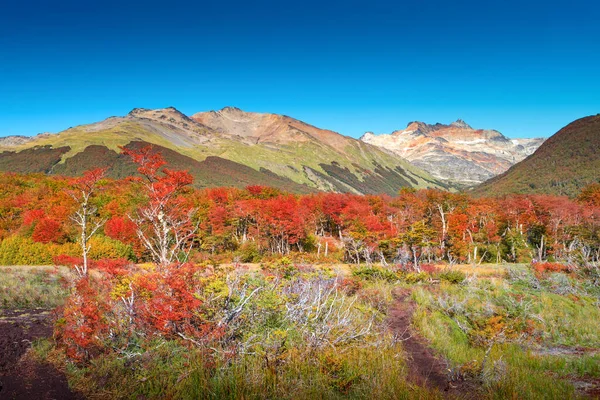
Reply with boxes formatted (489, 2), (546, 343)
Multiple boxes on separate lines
(473, 114), (600, 197)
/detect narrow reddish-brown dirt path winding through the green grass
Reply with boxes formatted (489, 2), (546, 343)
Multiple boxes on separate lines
(388, 289), (476, 399)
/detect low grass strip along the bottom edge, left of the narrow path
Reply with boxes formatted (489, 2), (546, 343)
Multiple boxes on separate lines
(37, 341), (441, 399)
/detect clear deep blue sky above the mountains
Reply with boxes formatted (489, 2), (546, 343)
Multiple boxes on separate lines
(0, 0), (600, 137)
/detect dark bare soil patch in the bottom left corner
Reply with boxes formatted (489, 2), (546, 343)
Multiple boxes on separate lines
(0, 309), (82, 400)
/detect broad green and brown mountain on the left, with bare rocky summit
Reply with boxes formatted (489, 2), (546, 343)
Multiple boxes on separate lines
(0, 107), (449, 194)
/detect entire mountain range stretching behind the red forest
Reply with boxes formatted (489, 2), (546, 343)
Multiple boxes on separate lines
(0, 107), (600, 197)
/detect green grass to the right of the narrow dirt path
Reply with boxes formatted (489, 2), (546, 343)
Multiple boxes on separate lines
(413, 266), (600, 399)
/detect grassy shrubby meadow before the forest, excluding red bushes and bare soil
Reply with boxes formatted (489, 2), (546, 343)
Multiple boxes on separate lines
(0, 263), (600, 399)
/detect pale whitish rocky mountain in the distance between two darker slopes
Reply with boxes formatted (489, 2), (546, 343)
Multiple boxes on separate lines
(360, 119), (544, 186)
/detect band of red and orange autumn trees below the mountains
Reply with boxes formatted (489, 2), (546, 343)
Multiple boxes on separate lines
(0, 148), (600, 270)
